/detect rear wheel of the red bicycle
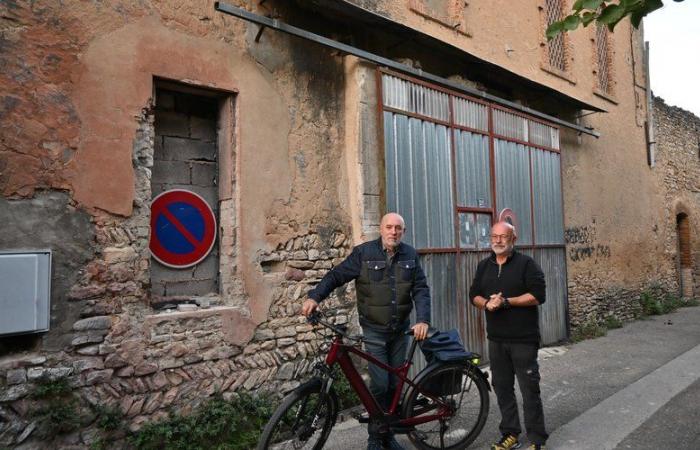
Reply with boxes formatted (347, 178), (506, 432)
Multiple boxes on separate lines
(403, 363), (489, 450)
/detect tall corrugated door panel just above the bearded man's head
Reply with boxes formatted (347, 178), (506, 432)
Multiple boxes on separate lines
(494, 139), (532, 244)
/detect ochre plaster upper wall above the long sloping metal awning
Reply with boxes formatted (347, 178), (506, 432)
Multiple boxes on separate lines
(350, 0), (641, 110)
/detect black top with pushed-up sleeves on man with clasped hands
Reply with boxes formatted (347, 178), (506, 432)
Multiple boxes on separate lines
(469, 251), (546, 343)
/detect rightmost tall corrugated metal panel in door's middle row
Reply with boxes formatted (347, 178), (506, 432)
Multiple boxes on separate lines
(530, 148), (564, 244)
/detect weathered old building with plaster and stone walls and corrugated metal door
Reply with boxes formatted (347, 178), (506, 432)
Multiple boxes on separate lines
(0, 0), (699, 445)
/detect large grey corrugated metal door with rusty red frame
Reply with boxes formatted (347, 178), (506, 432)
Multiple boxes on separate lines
(380, 71), (568, 364)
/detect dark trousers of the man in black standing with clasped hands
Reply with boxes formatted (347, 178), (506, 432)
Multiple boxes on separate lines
(489, 341), (549, 444)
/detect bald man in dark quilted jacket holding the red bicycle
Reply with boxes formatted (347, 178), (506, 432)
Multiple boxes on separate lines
(301, 213), (430, 450)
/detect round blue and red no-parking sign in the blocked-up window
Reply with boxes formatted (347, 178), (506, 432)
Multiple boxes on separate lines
(149, 189), (216, 269)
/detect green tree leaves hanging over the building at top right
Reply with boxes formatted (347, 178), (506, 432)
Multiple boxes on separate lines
(546, 0), (683, 39)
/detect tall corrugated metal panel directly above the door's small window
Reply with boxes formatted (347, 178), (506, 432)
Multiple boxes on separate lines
(455, 130), (491, 208)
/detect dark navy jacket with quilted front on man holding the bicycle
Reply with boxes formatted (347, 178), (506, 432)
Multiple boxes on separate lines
(308, 238), (430, 330)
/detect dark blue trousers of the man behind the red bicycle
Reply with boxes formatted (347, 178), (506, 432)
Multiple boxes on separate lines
(362, 327), (408, 435)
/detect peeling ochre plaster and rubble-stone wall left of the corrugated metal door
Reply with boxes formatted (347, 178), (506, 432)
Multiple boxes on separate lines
(0, 1), (355, 445)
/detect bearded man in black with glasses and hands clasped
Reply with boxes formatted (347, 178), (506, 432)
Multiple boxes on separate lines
(469, 222), (548, 450)
